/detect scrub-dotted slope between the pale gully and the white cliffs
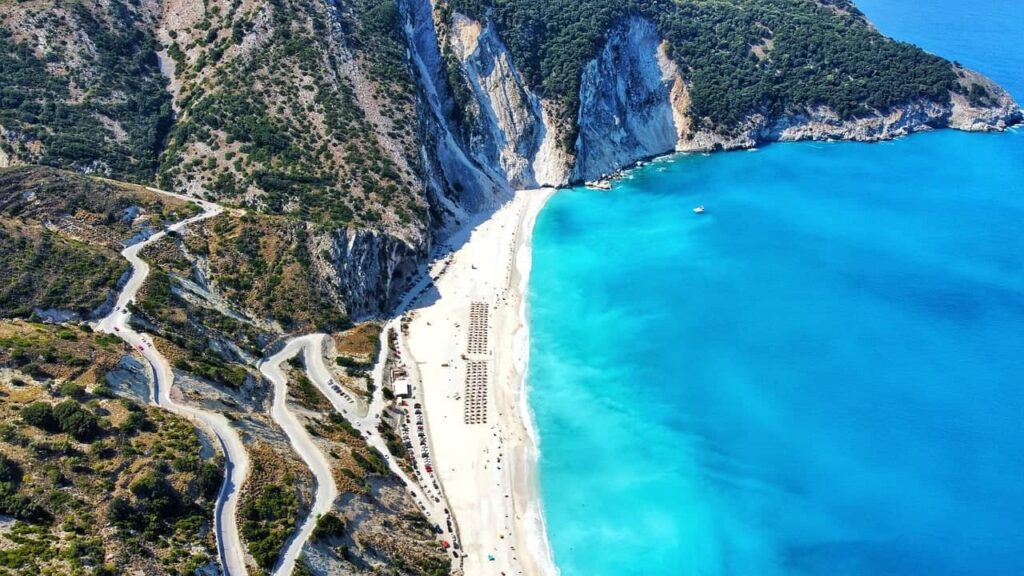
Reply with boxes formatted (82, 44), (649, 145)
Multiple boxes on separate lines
(161, 0), (425, 233)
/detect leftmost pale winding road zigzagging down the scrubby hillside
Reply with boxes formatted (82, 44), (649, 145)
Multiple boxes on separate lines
(93, 188), (249, 576)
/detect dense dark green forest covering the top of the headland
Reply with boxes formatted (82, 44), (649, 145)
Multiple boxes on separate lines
(451, 0), (955, 138)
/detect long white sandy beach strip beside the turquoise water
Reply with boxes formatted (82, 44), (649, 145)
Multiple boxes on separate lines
(402, 190), (557, 576)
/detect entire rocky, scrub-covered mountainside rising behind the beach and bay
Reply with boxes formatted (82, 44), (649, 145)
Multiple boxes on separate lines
(0, 0), (1021, 318)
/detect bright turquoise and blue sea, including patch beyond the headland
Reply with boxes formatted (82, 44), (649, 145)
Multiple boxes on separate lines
(528, 0), (1024, 576)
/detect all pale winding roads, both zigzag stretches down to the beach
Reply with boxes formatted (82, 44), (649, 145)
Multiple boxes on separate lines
(93, 188), (456, 576)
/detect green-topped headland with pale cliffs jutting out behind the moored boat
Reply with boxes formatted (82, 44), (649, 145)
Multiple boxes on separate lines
(436, 0), (1022, 184)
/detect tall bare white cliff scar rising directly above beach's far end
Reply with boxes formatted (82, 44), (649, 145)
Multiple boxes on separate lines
(400, 0), (572, 215)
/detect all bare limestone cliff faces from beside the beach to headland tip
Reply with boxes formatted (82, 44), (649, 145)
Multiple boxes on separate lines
(317, 0), (1020, 318)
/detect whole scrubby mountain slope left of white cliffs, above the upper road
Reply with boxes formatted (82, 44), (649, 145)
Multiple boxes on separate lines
(0, 0), (427, 233)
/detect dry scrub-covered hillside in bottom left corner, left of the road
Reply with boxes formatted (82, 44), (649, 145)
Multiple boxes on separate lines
(0, 322), (223, 576)
